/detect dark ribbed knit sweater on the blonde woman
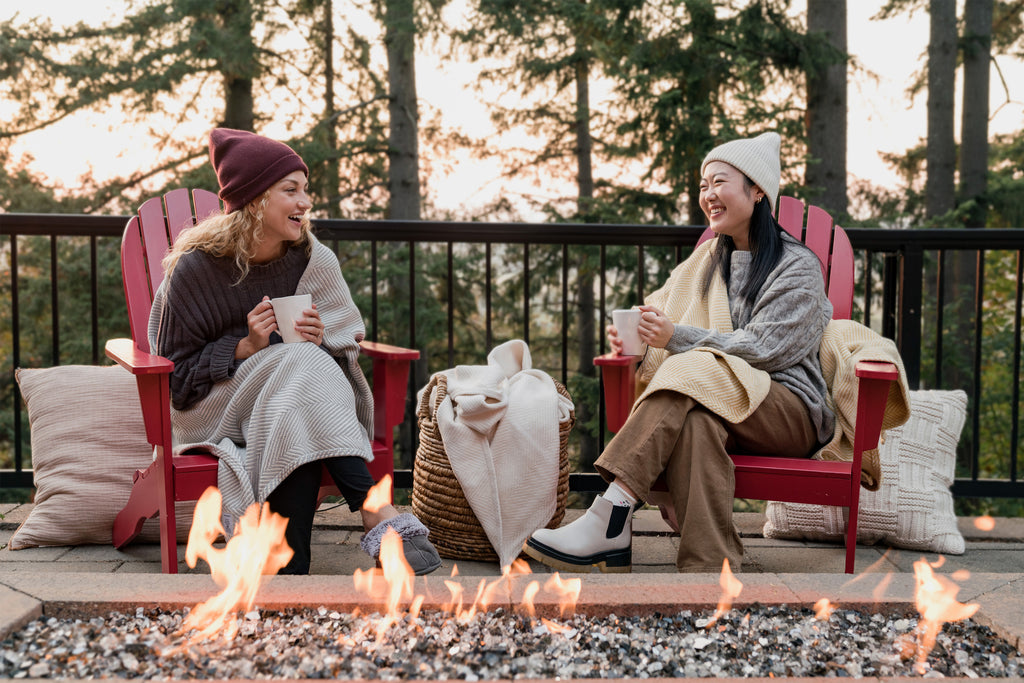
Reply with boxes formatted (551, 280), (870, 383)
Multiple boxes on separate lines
(157, 247), (309, 411)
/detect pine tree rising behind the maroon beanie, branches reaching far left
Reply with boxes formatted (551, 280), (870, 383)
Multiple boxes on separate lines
(0, 0), (278, 210)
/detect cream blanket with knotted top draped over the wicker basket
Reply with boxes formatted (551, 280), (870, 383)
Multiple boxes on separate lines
(429, 340), (572, 567)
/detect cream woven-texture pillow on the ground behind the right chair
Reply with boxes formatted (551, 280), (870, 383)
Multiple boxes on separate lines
(764, 390), (967, 555)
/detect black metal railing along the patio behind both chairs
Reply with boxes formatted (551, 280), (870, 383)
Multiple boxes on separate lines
(0, 214), (1024, 498)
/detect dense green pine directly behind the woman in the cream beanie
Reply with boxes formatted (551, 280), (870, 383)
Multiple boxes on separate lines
(609, 0), (844, 224)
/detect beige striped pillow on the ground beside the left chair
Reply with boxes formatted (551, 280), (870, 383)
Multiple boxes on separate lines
(9, 366), (195, 550)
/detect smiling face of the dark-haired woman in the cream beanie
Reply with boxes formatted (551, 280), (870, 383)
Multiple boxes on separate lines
(700, 161), (764, 251)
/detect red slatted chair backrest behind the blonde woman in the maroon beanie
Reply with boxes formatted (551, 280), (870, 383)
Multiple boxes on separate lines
(121, 188), (220, 351)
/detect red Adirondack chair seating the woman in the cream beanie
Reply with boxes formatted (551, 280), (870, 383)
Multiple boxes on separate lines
(594, 197), (899, 573)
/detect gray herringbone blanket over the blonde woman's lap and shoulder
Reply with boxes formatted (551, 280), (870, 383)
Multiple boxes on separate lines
(148, 242), (373, 535)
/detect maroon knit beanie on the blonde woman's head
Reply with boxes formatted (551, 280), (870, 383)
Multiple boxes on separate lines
(210, 128), (309, 213)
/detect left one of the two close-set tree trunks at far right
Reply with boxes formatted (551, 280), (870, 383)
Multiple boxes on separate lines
(925, 0), (956, 218)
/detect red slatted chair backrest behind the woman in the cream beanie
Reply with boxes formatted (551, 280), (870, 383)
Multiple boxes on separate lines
(697, 197), (854, 321)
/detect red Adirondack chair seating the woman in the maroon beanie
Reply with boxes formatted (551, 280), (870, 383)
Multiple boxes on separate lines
(105, 188), (420, 573)
